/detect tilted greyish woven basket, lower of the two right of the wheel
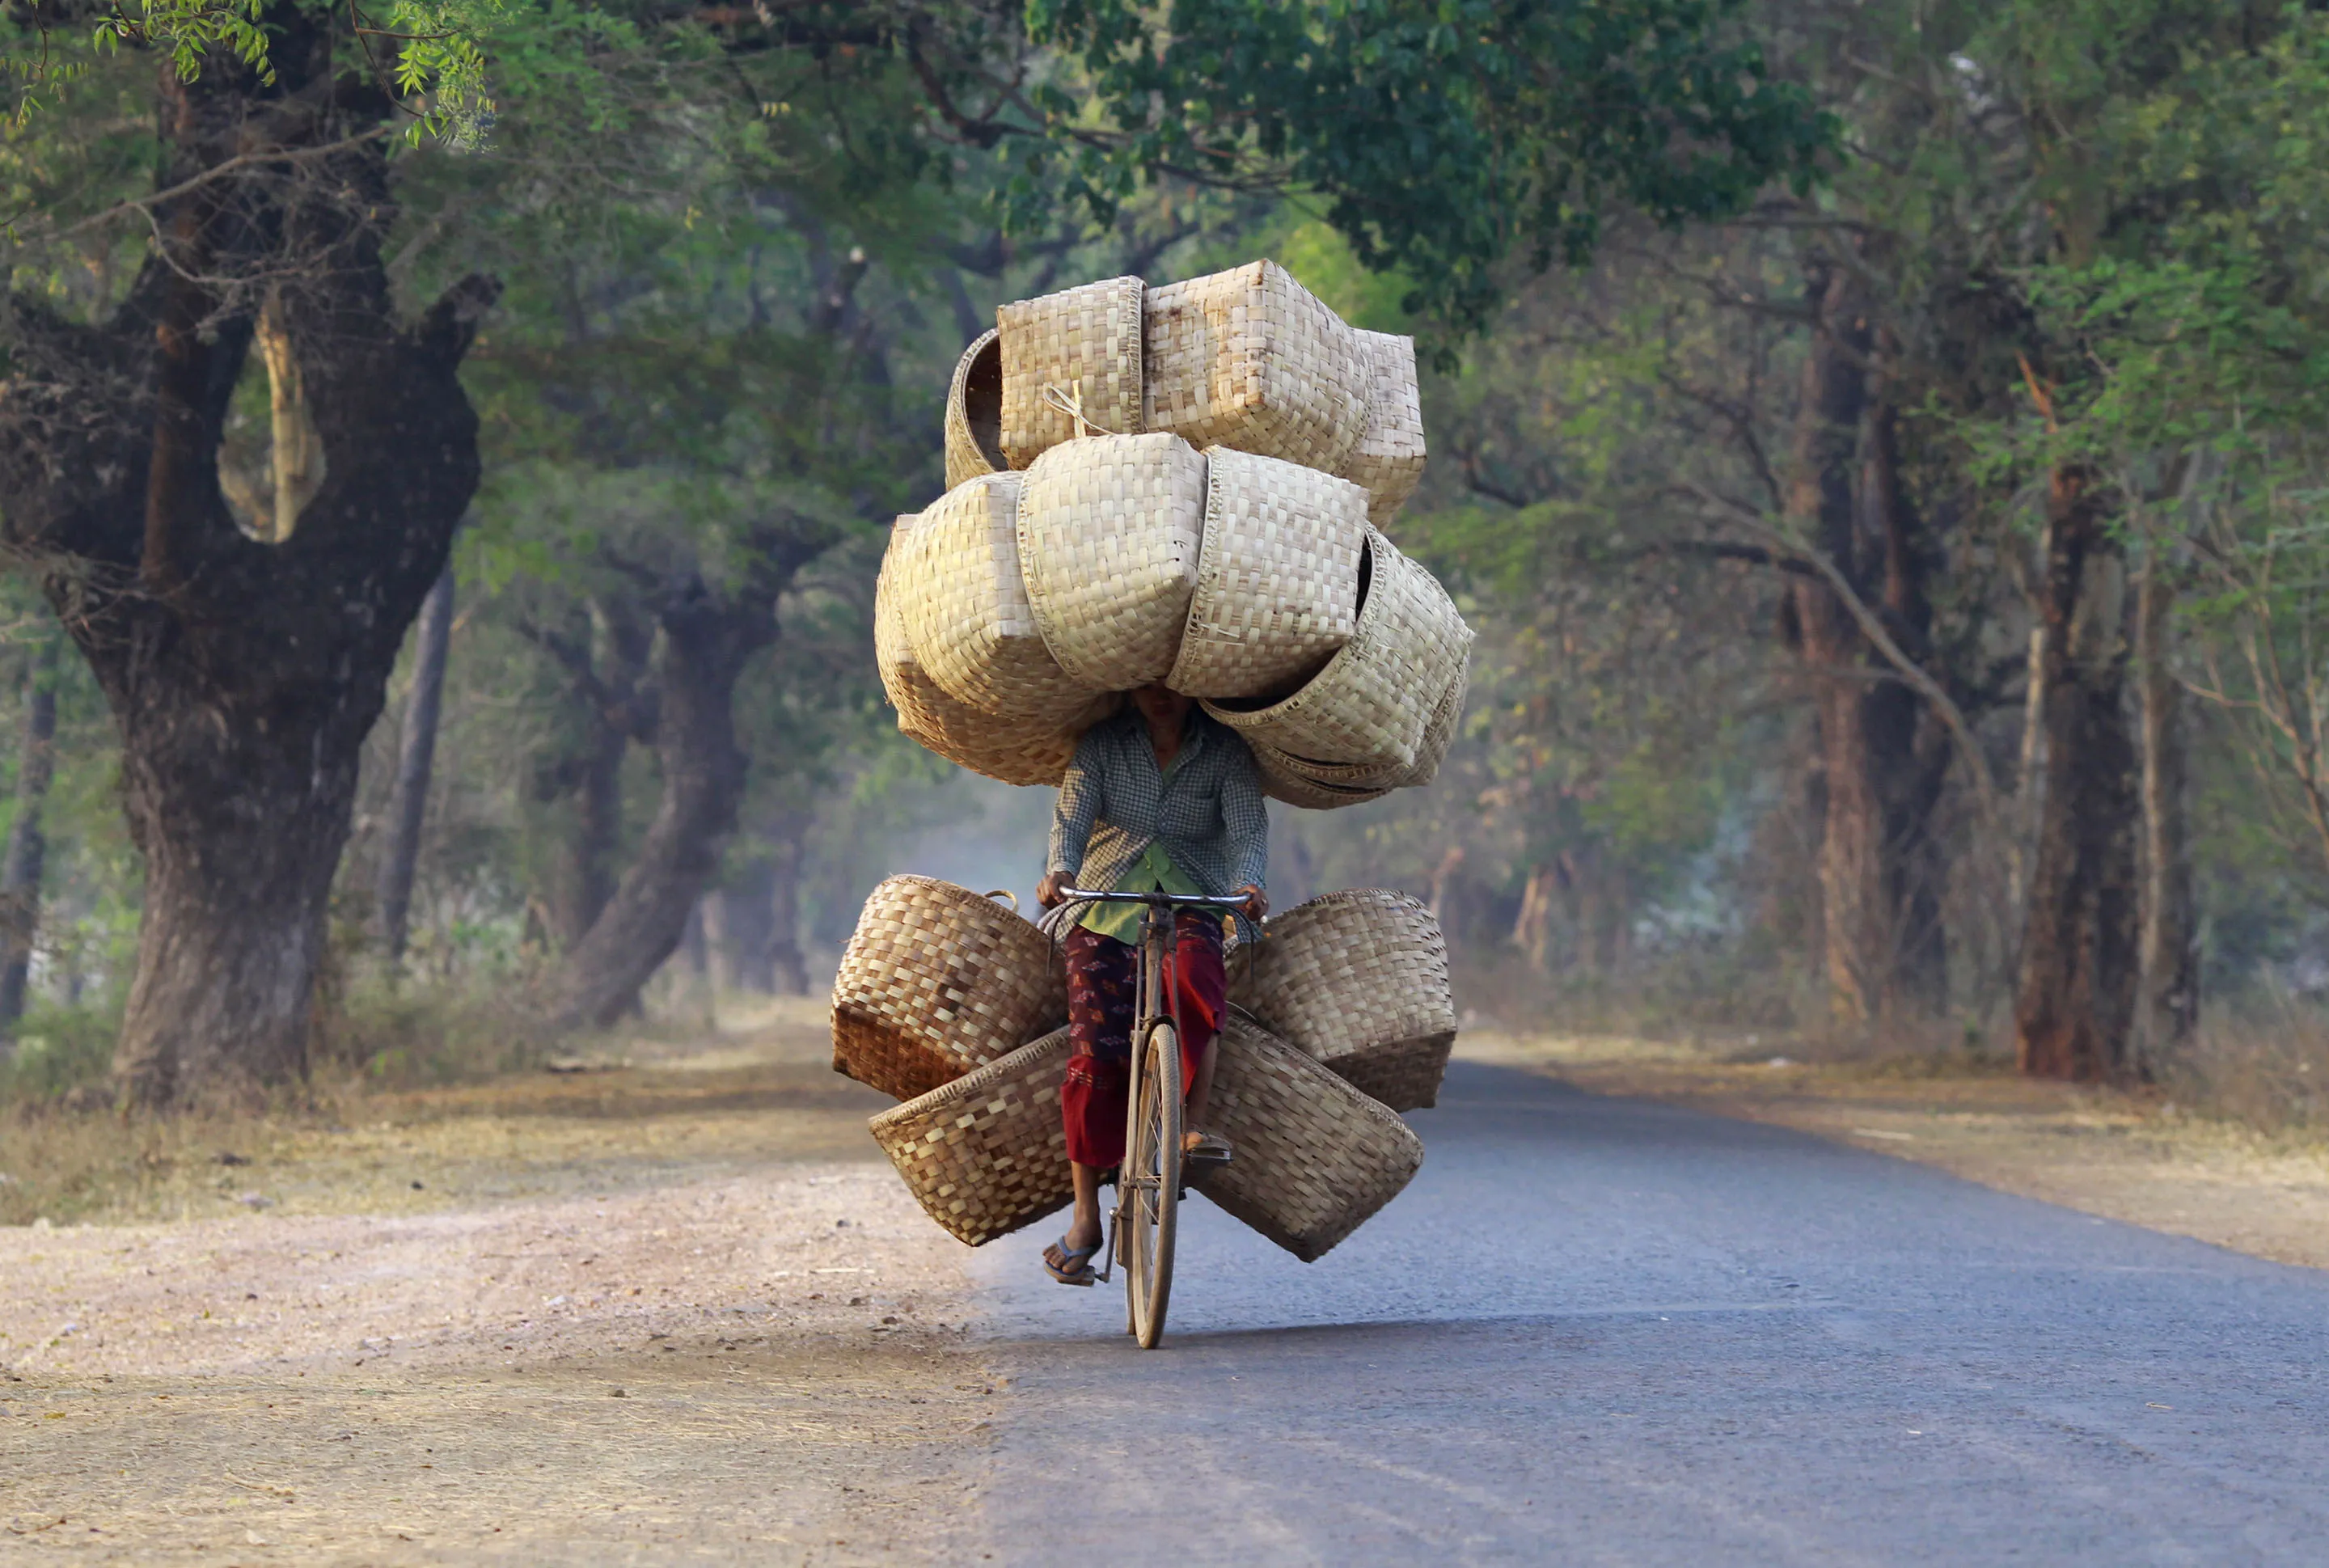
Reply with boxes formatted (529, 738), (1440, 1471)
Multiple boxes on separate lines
(1199, 1013), (1423, 1263)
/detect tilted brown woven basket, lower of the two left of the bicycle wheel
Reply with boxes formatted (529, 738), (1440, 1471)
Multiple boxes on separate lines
(866, 1029), (1076, 1246)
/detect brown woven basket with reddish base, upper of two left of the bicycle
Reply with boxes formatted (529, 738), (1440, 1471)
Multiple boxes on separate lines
(834, 876), (1067, 1100)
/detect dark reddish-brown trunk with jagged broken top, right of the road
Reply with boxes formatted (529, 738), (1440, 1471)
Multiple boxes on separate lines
(2014, 468), (2141, 1081)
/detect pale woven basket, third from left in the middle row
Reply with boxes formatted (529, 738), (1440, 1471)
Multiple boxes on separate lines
(1164, 447), (1367, 696)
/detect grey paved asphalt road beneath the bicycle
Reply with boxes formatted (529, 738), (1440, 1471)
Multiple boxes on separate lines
(959, 1063), (2329, 1568)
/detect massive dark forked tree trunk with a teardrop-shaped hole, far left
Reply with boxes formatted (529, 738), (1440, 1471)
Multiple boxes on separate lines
(0, 21), (492, 1105)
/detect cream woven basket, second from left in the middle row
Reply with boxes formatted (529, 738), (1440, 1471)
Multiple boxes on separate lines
(1018, 436), (1204, 692)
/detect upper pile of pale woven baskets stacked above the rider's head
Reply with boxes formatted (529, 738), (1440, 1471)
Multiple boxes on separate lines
(873, 261), (1472, 809)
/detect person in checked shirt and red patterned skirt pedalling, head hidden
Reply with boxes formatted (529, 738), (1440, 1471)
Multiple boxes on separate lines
(1037, 685), (1270, 1286)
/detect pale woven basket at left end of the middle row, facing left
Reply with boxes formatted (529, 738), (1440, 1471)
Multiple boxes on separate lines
(892, 473), (1097, 725)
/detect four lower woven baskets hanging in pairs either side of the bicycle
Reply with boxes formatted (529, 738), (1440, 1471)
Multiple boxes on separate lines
(834, 876), (1456, 1263)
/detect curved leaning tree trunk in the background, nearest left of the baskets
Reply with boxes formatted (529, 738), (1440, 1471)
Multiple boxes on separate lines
(543, 549), (826, 1028)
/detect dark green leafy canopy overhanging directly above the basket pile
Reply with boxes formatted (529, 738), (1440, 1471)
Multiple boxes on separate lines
(1008, 0), (1835, 331)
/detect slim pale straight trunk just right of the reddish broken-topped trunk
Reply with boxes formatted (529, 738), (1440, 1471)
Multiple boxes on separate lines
(2133, 552), (2201, 1076)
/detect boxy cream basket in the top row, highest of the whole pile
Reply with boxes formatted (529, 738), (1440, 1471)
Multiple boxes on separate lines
(1141, 261), (1374, 473)
